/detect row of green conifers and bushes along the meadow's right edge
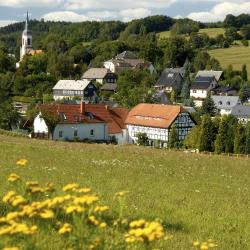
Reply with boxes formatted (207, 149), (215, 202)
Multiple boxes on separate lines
(184, 115), (250, 154)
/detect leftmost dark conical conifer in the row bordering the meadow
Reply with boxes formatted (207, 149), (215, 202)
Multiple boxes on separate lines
(199, 115), (214, 152)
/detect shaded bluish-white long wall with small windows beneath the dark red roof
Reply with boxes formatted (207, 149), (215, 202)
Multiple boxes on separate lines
(53, 123), (108, 141)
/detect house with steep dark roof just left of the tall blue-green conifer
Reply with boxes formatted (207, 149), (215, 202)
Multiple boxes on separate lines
(155, 68), (184, 93)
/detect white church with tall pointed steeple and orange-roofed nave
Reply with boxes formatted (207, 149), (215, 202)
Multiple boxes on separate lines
(17, 12), (43, 68)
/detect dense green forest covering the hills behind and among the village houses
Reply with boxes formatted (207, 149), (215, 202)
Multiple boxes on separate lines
(0, 14), (250, 128)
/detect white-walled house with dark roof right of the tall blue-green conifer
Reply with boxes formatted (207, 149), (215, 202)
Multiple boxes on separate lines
(190, 76), (217, 107)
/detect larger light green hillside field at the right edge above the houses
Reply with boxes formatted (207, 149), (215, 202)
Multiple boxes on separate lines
(209, 45), (250, 77)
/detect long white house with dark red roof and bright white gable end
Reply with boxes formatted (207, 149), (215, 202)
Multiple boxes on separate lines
(33, 102), (128, 144)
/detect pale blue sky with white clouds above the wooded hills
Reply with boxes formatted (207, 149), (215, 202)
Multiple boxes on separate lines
(0, 0), (250, 26)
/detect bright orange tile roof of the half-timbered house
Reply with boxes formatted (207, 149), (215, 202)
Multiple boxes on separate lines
(126, 103), (187, 128)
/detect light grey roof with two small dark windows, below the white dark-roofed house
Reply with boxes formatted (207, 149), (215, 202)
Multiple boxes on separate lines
(211, 95), (241, 109)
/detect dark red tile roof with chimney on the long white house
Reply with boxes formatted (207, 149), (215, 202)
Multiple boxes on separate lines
(40, 104), (128, 134)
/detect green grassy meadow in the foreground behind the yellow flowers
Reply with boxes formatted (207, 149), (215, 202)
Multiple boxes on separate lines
(0, 135), (250, 250)
